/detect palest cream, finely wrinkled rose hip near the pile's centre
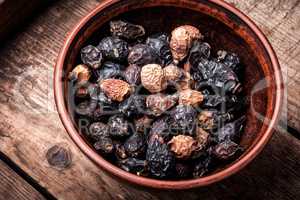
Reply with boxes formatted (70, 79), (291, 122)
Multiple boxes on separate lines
(141, 64), (166, 93)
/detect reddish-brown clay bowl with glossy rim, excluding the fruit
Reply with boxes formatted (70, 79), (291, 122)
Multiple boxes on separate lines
(54, 0), (283, 189)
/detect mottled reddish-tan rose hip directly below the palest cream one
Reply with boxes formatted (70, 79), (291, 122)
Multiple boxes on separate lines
(146, 93), (178, 116)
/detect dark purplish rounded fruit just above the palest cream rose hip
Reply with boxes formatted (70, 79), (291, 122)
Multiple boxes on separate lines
(128, 44), (159, 67)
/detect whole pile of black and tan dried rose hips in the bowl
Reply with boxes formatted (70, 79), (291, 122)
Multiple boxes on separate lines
(69, 21), (245, 179)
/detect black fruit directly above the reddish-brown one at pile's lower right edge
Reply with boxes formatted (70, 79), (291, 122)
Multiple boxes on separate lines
(215, 116), (245, 142)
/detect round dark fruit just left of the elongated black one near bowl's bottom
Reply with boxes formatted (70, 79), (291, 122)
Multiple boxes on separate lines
(124, 133), (146, 158)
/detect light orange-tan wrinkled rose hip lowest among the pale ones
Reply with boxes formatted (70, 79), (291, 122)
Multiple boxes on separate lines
(168, 135), (198, 159)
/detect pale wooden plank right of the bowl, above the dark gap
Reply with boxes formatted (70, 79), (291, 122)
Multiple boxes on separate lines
(226, 0), (300, 131)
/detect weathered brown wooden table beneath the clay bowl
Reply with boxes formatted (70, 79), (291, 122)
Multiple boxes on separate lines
(0, 0), (300, 200)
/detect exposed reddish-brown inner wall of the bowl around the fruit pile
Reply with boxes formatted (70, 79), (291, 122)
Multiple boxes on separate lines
(59, 0), (276, 187)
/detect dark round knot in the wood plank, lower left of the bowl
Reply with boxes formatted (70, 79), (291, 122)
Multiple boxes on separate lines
(46, 145), (72, 169)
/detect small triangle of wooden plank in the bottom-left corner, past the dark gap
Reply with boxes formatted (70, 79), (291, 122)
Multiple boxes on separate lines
(0, 160), (45, 200)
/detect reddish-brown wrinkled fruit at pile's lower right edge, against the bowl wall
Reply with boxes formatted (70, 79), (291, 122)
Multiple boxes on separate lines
(212, 140), (241, 160)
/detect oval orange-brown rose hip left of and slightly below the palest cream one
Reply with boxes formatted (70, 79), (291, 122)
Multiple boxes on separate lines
(100, 79), (130, 102)
